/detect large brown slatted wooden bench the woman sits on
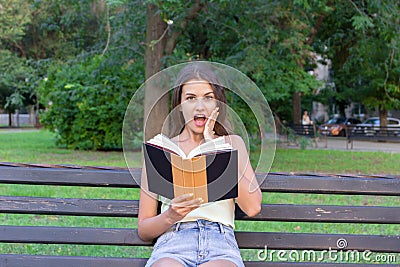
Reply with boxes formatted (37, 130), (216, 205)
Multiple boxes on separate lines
(0, 164), (400, 267)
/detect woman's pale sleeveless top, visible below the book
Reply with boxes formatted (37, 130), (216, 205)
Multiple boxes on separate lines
(160, 197), (235, 228)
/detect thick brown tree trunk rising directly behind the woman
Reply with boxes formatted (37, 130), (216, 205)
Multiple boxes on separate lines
(144, 4), (169, 140)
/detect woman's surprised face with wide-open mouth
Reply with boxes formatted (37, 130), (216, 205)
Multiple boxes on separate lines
(180, 80), (217, 134)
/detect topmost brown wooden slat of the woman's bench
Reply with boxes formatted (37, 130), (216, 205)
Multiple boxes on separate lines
(0, 166), (400, 196)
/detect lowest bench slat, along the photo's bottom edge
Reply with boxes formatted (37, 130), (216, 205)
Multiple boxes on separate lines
(0, 254), (397, 267)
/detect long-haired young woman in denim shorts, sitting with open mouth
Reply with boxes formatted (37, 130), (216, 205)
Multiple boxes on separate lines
(138, 63), (262, 267)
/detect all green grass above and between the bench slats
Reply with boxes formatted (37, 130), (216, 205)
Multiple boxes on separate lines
(0, 130), (400, 260)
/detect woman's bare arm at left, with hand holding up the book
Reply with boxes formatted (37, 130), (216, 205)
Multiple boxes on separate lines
(138, 166), (202, 241)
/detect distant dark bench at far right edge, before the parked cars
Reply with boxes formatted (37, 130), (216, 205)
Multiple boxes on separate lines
(346, 126), (400, 149)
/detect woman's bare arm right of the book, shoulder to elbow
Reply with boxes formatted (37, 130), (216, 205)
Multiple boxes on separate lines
(227, 135), (262, 217)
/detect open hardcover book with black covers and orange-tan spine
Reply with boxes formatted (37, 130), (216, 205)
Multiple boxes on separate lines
(143, 134), (238, 202)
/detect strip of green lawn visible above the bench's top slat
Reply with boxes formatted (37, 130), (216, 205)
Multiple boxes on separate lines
(0, 130), (400, 174)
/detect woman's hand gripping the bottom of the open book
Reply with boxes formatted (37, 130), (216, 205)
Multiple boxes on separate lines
(167, 194), (203, 223)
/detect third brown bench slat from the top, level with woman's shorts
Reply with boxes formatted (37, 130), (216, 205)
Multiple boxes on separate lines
(0, 226), (400, 252)
